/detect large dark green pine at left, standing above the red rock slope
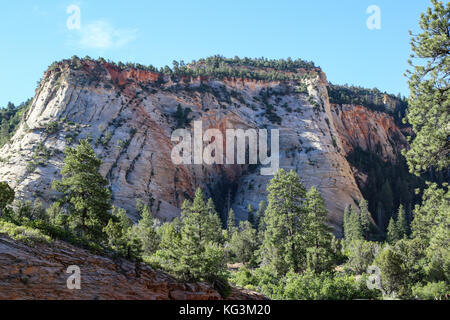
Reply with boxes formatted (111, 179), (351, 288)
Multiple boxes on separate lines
(53, 139), (111, 239)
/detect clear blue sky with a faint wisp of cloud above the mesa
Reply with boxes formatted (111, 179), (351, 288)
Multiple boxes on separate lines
(0, 0), (430, 107)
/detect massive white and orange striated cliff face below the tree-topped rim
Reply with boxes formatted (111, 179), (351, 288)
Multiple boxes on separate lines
(0, 60), (404, 234)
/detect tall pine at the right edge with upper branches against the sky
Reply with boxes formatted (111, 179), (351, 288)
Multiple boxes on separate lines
(404, 0), (450, 175)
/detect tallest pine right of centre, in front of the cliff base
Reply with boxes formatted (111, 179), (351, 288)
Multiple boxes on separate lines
(262, 169), (307, 275)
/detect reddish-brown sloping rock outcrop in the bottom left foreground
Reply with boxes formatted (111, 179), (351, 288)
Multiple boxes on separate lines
(0, 234), (266, 300)
